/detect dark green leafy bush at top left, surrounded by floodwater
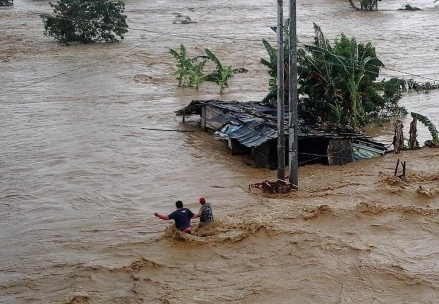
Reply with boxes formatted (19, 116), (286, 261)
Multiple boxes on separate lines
(41, 0), (128, 44)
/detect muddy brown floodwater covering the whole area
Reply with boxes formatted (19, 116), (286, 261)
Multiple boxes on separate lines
(0, 0), (439, 304)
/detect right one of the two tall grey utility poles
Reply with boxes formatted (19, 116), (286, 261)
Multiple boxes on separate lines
(288, 0), (299, 190)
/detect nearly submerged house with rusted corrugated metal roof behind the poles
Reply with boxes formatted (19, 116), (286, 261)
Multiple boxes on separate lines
(176, 100), (387, 169)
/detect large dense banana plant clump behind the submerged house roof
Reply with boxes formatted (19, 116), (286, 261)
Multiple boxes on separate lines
(261, 22), (407, 129)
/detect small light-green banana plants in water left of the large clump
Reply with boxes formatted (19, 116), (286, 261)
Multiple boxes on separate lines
(170, 44), (247, 95)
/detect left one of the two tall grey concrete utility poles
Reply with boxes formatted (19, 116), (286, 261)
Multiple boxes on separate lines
(277, 0), (285, 180)
